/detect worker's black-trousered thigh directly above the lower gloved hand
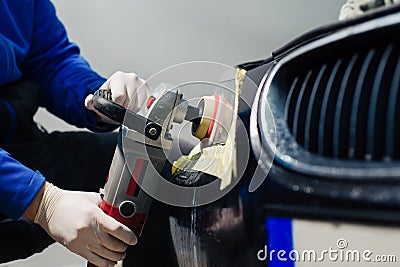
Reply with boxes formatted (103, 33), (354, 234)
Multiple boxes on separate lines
(2, 132), (117, 192)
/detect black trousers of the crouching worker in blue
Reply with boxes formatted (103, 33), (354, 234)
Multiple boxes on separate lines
(0, 82), (116, 262)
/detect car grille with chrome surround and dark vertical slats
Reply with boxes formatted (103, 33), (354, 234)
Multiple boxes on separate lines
(252, 14), (400, 180)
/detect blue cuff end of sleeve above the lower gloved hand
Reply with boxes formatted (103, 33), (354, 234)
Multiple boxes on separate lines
(0, 148), (45, 220)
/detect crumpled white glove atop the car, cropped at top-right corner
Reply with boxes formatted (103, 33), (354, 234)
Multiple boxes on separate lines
(339, 0), (400, 20)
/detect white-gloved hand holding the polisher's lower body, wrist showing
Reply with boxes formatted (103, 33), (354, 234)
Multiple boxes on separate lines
(34, 184), (137, 267)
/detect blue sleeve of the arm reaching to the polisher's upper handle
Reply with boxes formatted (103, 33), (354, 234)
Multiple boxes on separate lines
(22, 0), (105, 130)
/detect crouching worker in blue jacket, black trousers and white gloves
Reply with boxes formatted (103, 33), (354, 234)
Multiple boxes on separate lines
(0, 0), (173, 266)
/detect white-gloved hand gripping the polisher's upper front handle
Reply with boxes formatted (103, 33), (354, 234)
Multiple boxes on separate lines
(85, 71), (151, 122)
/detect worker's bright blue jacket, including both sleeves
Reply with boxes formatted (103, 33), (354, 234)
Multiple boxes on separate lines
(0, 0), (105, 219)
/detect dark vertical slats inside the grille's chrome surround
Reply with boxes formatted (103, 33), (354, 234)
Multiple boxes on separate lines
(284, 40), (400, 161)
